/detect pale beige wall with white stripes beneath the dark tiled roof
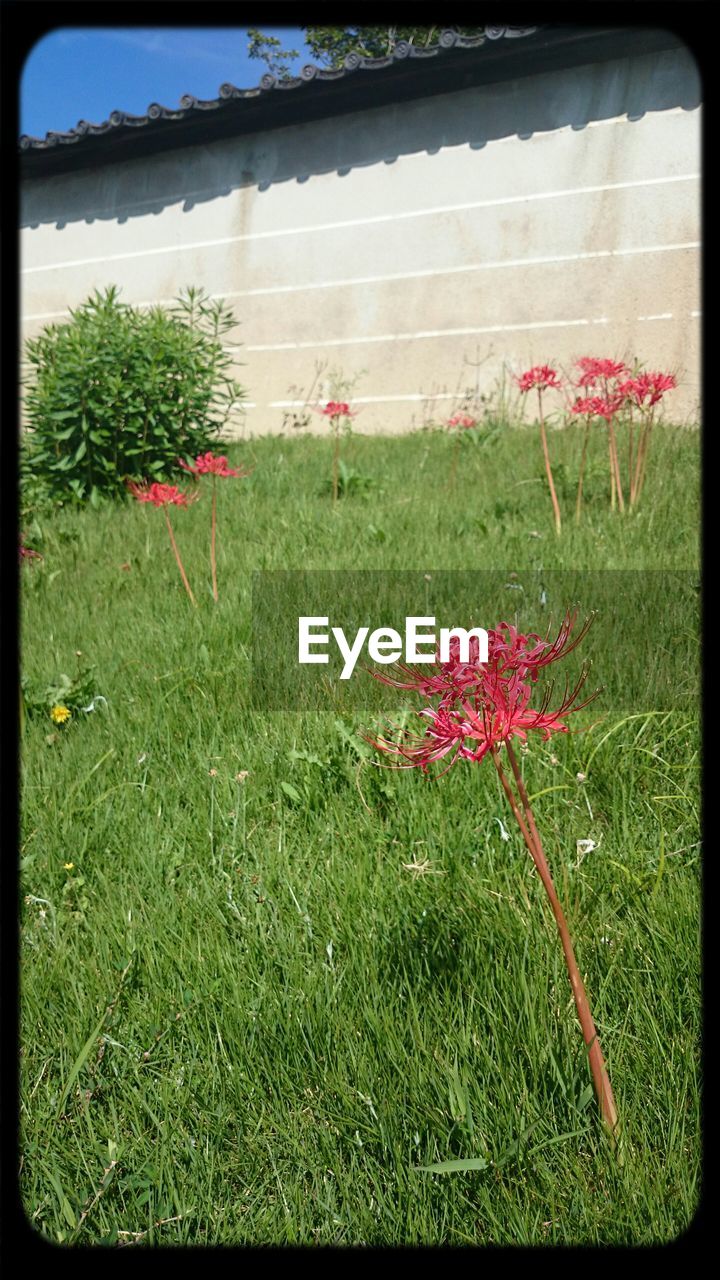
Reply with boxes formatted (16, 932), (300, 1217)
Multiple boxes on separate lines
(20, 49), (701, 434)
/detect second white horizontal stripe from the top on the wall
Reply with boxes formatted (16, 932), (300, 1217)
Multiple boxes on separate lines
(23, 241), (701, 320)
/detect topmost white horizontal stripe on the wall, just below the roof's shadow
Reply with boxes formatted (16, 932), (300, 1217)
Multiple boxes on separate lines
(22, 173), (700, 275)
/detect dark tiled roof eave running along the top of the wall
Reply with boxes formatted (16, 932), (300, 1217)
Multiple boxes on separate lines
(20, 26), (680, 178)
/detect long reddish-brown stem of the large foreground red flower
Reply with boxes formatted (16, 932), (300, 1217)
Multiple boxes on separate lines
(493, 742), (618, 1143)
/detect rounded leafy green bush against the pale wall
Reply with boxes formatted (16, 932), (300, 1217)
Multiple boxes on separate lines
(22, 285), (245, 507)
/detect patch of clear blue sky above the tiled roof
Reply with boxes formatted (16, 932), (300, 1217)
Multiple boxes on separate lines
(19, 26), (307, 137)
